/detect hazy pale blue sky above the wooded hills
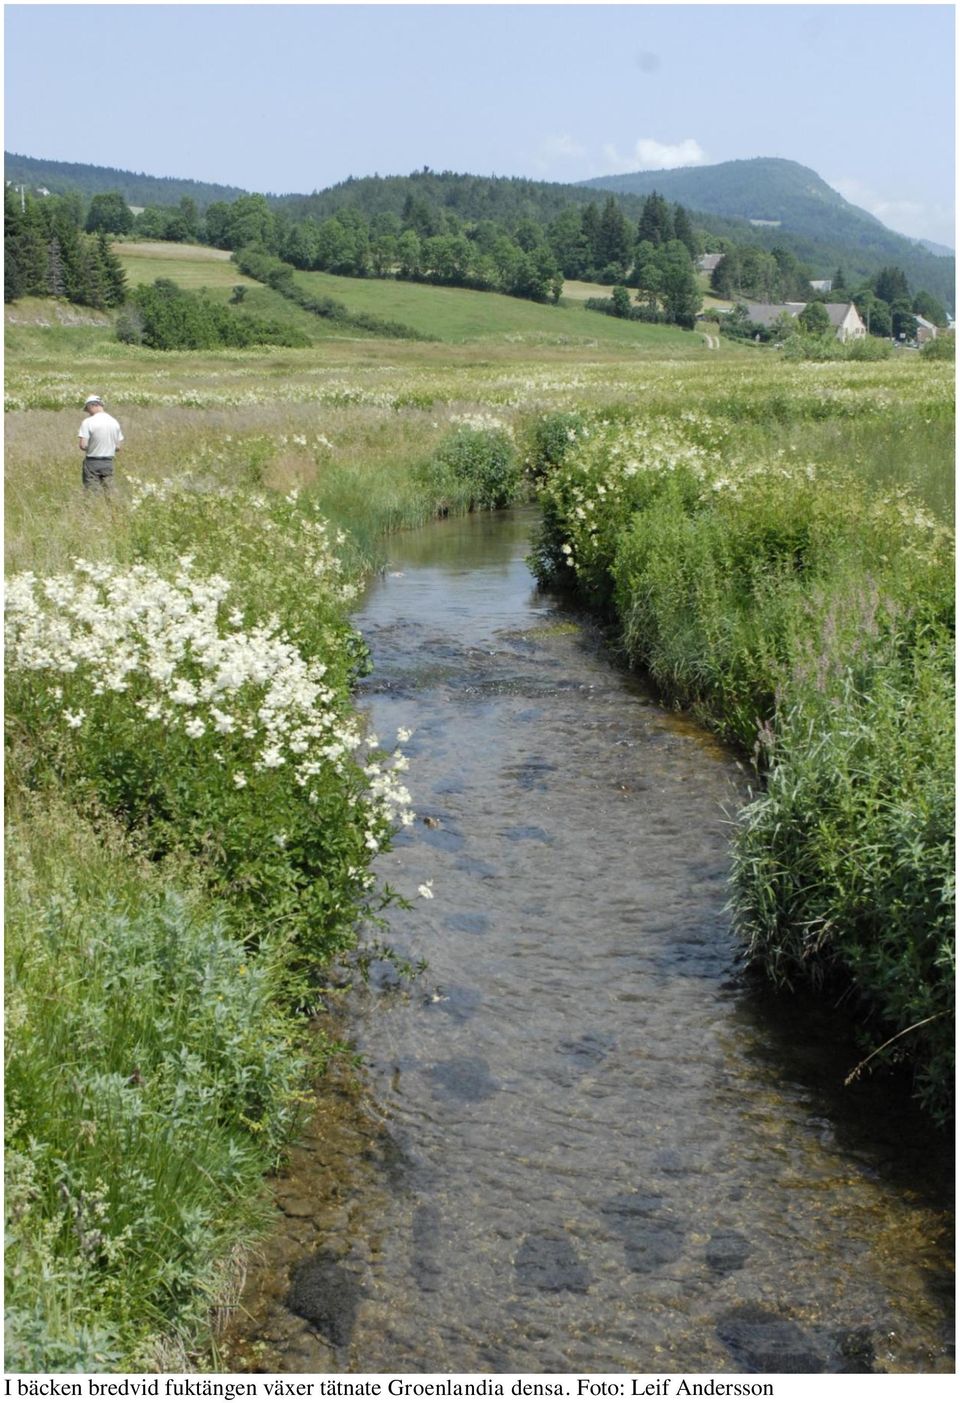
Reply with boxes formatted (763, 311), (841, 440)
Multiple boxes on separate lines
(4, 4), (954, 244)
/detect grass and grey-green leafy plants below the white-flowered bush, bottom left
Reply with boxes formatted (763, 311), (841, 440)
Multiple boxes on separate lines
(6, 791), (306, 1374)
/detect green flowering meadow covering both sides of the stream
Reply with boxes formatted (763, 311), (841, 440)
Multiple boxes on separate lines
(6, 246), (953, 1372)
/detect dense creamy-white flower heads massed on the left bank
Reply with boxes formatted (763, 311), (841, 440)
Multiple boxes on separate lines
(6, 558), (410, 850)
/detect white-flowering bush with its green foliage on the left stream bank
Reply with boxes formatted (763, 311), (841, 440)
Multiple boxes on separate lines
(6, 556), (413, 955)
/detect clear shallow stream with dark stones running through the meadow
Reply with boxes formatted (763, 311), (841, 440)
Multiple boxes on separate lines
(225, 512), (953, 1374)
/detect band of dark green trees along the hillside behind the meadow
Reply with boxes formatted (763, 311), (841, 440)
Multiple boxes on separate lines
(6, 173), (946, 338)
